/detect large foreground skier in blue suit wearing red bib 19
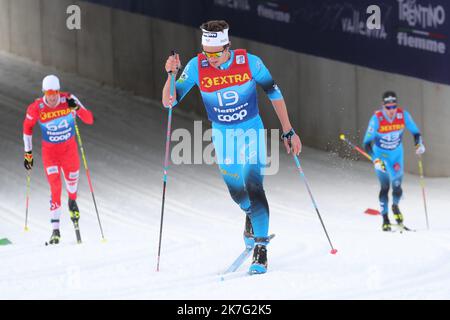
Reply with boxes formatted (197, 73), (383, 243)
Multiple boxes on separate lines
(162, 20), (302, 273)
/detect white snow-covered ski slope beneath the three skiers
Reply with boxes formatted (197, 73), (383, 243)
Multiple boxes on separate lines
(0, 54), (450, 299)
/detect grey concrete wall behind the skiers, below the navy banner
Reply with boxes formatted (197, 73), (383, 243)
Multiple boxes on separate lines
(0, 0), (450, 176)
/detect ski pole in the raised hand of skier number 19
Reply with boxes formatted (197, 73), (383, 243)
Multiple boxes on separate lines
(156, 51), (175, 272)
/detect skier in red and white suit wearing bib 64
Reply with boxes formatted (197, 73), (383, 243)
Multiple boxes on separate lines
(23, 75), (94, 244)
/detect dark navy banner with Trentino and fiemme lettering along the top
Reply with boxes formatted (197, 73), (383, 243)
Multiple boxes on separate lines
(82, 0), (450, 84)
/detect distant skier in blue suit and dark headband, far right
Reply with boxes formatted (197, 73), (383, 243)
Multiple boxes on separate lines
(364, 91), (425, 231)
